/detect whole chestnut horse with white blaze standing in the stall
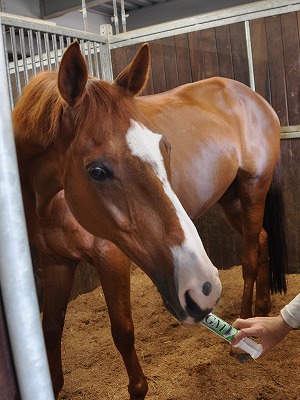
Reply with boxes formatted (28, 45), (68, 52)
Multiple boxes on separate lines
(13, 42), (286, 399)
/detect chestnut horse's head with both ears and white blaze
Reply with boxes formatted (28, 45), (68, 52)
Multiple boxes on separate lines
(58, 42), (221, 324)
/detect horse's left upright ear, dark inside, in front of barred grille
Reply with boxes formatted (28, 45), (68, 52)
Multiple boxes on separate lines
(58, 41), (88, 105)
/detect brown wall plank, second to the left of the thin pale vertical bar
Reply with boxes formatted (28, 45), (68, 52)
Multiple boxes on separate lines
(215, 25), (233, 79)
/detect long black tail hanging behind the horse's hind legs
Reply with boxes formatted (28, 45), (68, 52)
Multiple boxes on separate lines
(264, 163), (288, 293)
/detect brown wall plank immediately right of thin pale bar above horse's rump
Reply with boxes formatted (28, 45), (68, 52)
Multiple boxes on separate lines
(250, 18), (271, 103)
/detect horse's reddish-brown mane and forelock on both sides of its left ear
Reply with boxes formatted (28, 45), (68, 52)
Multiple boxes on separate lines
(13, 72), (129, 148)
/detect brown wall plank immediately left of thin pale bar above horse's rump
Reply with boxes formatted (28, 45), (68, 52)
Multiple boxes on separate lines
(229, 22), (250, 86)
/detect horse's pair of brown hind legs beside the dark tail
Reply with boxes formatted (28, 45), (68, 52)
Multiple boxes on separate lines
(219, 178), (271, 318)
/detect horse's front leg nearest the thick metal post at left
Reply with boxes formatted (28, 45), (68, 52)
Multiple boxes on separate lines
(42, 257), (76, 399)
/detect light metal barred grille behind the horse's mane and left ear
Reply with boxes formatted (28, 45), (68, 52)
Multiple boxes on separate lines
(0, 14), (112, 108)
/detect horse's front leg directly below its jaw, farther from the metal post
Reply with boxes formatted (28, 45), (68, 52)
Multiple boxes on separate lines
(93, 244), (148, 400)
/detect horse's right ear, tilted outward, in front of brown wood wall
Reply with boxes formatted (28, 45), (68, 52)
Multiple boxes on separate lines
(115, 43), (150, 96)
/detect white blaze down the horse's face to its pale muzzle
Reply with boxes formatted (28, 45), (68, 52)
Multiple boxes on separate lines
(126, 120), (220, 322)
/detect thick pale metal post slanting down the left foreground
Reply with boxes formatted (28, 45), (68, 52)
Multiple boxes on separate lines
(0, 18), (54, 400)
